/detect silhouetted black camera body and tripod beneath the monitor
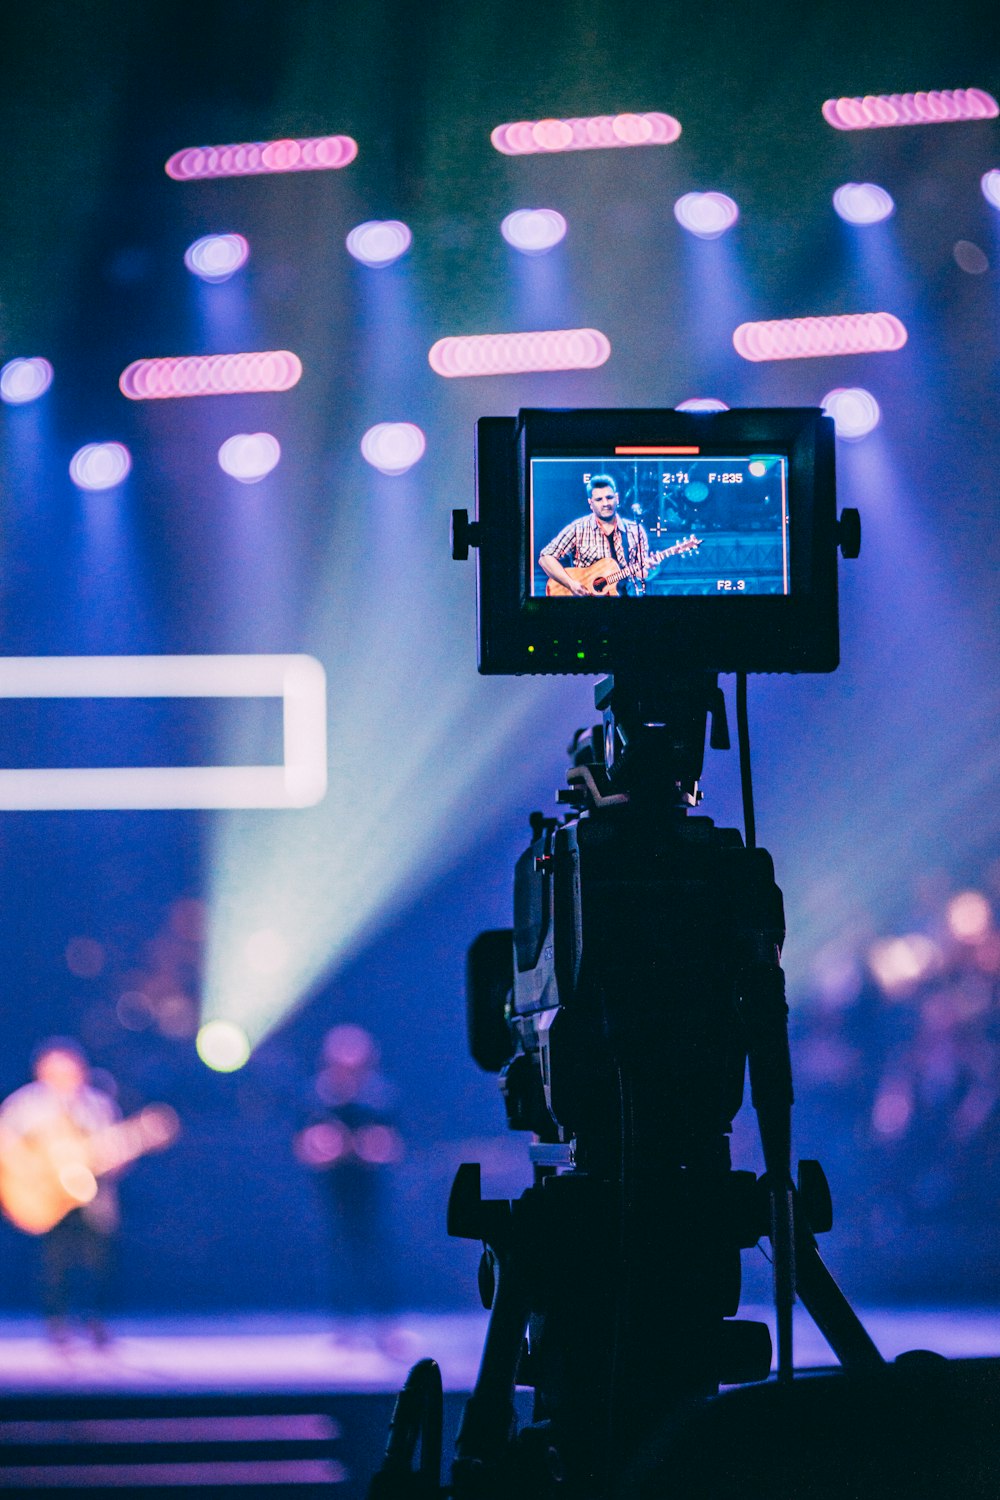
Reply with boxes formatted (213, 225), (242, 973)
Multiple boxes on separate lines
(371, 674), (882, 1500)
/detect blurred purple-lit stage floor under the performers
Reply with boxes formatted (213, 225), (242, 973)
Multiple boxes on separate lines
(0, 1307), (1000, 1395)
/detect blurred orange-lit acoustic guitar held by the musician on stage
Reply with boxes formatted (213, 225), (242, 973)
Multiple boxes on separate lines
(0, 1104), (180, 1235)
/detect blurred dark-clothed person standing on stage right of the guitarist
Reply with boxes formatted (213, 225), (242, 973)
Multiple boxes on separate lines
(294, 1025), (403, 1313)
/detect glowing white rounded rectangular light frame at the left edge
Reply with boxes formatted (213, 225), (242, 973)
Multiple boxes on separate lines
(0, 654), (327, 812)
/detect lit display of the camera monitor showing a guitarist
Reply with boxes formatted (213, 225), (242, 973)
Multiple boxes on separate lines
(528, 452), (792, 599)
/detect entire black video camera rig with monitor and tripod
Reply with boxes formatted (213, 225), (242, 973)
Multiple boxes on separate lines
(373, 408), (941, 1500)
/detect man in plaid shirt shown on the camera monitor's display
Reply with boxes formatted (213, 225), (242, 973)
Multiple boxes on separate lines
(538, 474), (651, 599)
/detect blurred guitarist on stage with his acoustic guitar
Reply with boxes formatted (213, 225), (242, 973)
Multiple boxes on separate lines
(0, 1037), (177, 1347)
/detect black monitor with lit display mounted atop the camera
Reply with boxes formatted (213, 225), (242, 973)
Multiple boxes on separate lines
(472, 408), (838, 674)
